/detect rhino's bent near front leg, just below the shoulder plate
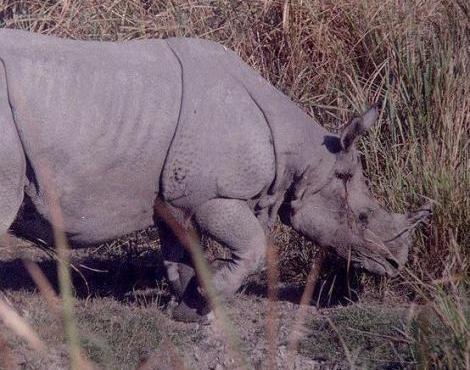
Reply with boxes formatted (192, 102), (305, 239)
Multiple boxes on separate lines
(195, 199), (267, 297)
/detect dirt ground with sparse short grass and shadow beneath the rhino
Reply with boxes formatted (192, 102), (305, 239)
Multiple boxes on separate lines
(0, 235), (415, 370)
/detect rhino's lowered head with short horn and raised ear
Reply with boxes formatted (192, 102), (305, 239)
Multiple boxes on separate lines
(291, 107), (431, 276)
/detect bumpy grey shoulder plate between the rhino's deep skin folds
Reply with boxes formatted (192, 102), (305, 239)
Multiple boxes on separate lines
(162, 39), (275, 209)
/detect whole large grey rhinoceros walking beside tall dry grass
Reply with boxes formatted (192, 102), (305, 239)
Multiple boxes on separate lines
(0, 30), (429, 320)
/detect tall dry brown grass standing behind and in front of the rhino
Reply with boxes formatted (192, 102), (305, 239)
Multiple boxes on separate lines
(0, 0), (470, 369)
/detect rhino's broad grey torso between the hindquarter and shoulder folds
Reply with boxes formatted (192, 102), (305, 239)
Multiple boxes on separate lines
(0, 30), (181, 243)
